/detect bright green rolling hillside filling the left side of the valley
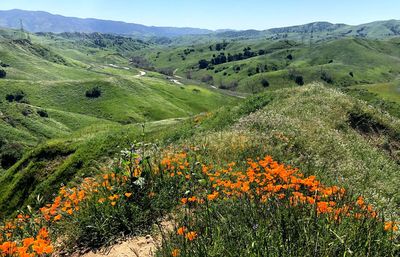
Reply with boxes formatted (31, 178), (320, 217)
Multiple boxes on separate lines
(0, 30), (237, 216)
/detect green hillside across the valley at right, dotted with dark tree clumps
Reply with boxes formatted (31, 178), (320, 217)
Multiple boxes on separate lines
(147, 38), (400, 92)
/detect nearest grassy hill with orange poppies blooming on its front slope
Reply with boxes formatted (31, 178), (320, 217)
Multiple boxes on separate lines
(0, 84), (400, 256)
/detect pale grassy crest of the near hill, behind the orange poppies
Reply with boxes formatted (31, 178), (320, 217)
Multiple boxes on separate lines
(169, 85), (400, 212)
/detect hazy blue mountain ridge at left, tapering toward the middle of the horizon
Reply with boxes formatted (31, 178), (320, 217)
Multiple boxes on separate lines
(0, 9), (213, 37)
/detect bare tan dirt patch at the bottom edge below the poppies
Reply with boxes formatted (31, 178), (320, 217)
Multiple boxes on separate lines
(72, 218), (173, 257)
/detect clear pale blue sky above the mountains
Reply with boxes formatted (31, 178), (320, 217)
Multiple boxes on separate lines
(0, 0), (400, 29)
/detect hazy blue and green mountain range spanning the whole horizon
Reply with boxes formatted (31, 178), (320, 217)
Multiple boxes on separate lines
(0, 9), (400, 40)
